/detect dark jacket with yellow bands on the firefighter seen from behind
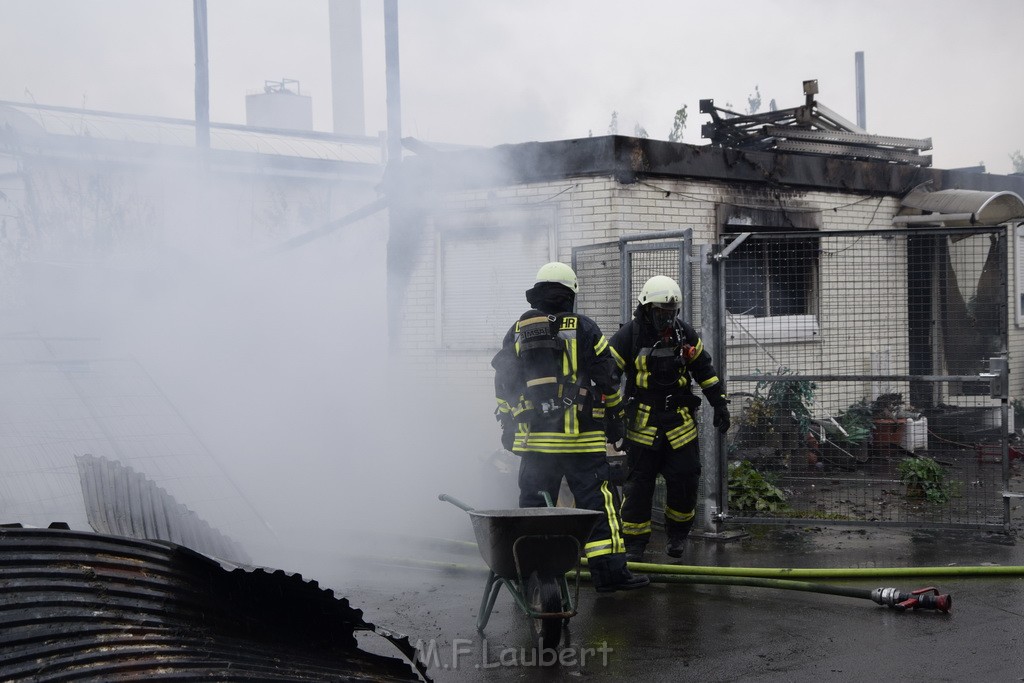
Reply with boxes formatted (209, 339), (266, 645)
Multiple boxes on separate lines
(492, 306), (622, 454)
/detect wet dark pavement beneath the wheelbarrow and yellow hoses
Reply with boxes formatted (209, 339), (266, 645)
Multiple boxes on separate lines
(321, 524), (1024, 683)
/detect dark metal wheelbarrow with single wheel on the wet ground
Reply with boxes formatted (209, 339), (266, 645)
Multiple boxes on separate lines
(438, 494), (601, 649)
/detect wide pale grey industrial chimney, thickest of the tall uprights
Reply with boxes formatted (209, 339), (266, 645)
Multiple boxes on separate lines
(328, 0), (367, 135)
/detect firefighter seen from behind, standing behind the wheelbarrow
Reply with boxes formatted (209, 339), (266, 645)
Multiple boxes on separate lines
(492, 261), (650, 592)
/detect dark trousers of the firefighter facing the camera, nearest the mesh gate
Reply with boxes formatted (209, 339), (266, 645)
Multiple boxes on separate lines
(622, 438), (700, 550)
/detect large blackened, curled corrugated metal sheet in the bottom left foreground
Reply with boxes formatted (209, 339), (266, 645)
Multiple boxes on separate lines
(0, 528), (426, 681)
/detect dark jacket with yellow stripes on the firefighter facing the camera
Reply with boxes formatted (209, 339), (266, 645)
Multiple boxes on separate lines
(609, 315), (728, 450)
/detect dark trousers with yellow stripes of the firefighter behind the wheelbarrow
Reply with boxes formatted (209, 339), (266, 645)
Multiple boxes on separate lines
(519, 453), (626, 566)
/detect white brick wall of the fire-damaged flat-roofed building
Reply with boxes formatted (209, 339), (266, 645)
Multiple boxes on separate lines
(398, 178), (1024, 414)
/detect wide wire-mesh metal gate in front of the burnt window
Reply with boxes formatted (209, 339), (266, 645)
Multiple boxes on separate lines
(716, 226), (1013, 529)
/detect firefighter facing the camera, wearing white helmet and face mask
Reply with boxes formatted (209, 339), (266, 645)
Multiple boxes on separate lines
(609, 275), (729, 562)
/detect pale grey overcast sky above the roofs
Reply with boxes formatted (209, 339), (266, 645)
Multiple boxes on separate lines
(0, 0), (1024, 173)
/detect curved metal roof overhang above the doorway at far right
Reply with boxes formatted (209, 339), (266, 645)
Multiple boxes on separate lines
(893, 189), (1024, 227)
